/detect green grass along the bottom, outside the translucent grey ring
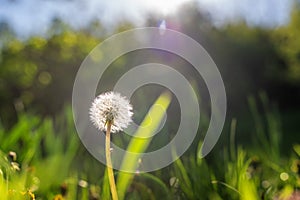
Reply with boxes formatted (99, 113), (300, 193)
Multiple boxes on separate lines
(0, 97), (300, 200)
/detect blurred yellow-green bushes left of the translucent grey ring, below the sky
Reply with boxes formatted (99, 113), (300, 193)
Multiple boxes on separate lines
(0, 29), (100, 127)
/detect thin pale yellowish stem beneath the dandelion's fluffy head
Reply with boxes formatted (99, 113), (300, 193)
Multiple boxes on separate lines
(105, 121), (118, 200)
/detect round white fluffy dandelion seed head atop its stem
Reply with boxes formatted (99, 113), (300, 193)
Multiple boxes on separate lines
(90, 92), (133, 133)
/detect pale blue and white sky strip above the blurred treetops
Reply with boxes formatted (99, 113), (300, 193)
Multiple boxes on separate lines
(0, 0), (293, 37)
